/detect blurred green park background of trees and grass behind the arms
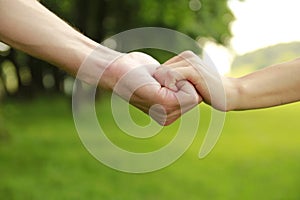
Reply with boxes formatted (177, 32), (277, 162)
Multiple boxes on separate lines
(0, 0), (300, 199)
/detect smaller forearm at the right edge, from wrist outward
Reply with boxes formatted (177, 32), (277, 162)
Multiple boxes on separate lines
(225, 59), (300, 110)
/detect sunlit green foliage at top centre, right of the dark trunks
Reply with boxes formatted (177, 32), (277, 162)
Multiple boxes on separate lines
(124, 0), (234, 44)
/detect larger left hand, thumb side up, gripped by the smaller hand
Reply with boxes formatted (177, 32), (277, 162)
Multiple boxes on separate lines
(103, 52), (202, 125)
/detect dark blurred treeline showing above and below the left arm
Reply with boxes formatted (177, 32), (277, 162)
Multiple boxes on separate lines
(0, 0), (234, 98)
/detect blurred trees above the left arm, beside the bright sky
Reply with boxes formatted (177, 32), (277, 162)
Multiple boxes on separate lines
(41, 0), (234, 44)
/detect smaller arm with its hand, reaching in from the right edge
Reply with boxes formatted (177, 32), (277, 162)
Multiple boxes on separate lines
(154, 51), (300, 111)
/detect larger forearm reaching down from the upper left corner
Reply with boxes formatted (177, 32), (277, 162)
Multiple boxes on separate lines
(0, 0), (120, 82)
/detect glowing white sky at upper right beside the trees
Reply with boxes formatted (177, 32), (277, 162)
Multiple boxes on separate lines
(204, 0), (300, 74)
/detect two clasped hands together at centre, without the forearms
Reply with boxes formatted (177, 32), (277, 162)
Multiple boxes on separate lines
(104, 51), (226, 125)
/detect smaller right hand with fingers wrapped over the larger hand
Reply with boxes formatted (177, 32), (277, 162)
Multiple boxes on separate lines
(154, 51), (228, 111)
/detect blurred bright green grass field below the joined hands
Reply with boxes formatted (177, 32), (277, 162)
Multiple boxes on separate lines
(0, 94), (300, 200)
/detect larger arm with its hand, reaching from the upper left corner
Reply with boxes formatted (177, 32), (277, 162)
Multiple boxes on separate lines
(0, 0), (202, 125)
